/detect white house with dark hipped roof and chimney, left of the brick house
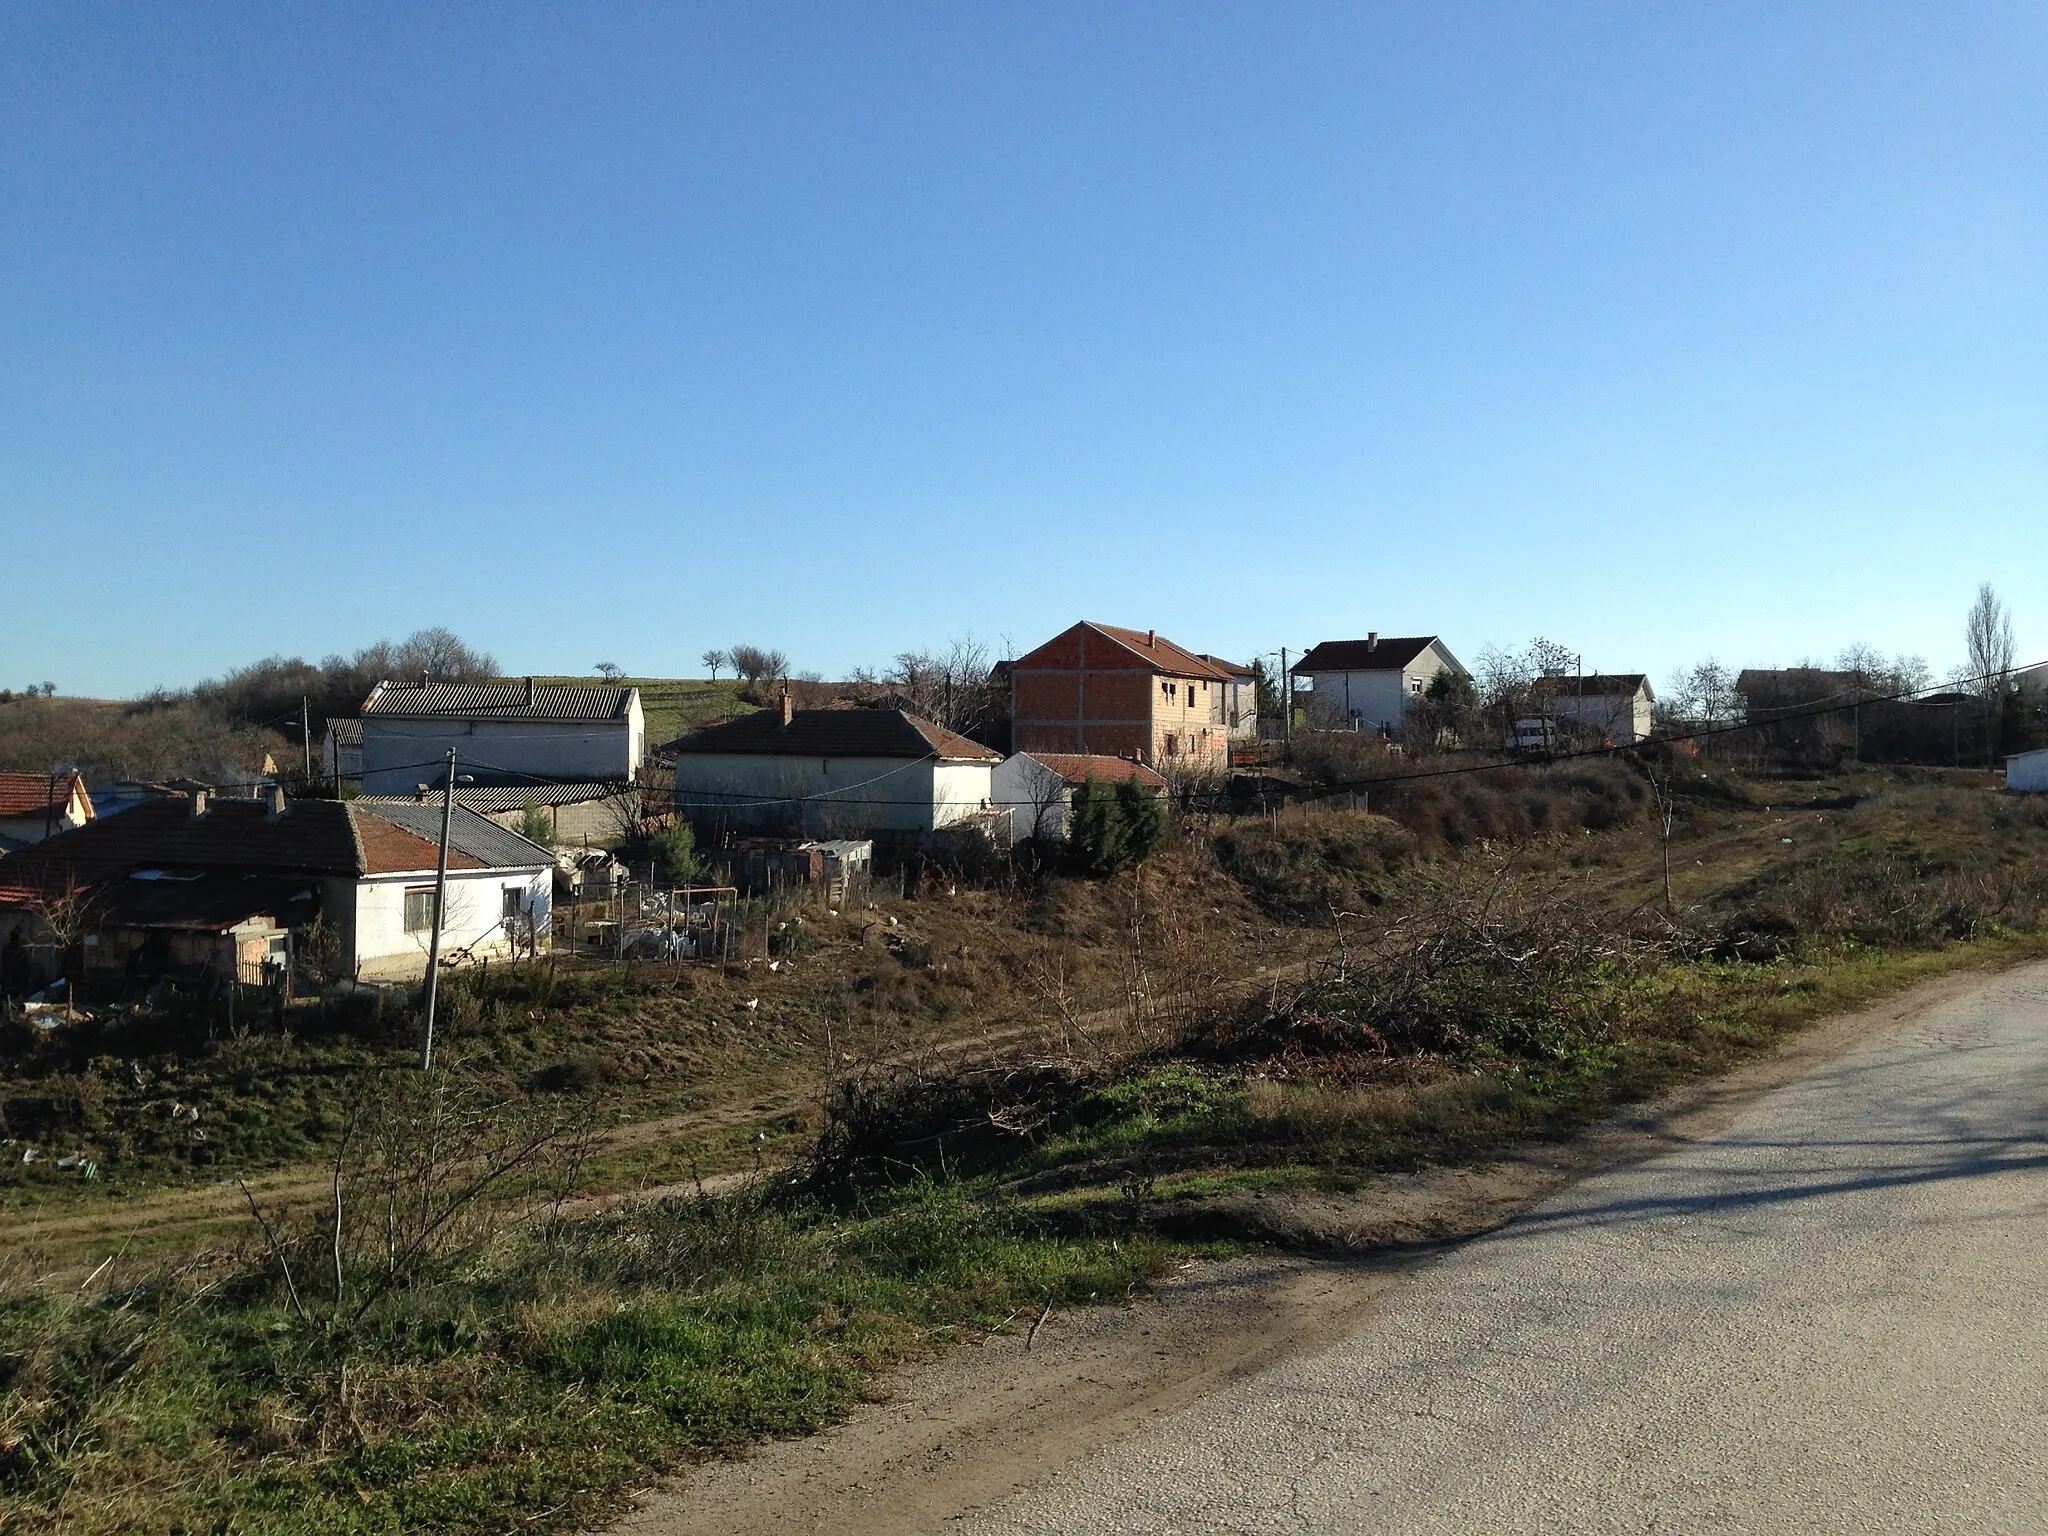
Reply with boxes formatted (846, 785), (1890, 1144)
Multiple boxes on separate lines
(666, 694), (1001, 846)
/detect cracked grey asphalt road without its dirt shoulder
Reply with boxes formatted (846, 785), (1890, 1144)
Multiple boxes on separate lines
(954, 965), (2048, 1536)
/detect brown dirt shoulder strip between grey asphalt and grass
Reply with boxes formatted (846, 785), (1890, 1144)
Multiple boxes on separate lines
(614, 969), (2015, 1536)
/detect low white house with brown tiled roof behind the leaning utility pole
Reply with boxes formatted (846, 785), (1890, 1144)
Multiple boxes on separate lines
(0, 791), (555, 981)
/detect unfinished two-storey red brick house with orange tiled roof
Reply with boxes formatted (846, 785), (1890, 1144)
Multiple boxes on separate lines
(1010, 621), (1231, 772)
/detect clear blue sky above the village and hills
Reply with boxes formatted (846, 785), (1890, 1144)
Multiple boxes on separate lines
(0, 0), (2048, 694)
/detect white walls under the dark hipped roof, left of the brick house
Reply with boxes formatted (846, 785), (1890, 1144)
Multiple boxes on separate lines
(676, 752), (995, 838)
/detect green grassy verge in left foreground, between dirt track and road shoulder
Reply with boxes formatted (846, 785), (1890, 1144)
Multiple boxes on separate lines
(0, 1182), (1186, 1534)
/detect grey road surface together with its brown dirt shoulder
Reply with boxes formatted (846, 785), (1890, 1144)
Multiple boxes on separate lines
(621, 963), (2048, 1536)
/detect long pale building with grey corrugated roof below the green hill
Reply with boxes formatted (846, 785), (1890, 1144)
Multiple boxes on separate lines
(360, 678), (647, 795)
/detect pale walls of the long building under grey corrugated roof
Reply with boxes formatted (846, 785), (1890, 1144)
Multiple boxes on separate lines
(362, 715), (645, 795)
